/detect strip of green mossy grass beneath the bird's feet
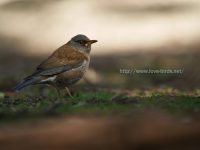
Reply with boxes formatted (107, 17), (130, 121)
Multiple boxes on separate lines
(0, 89), (200, 121)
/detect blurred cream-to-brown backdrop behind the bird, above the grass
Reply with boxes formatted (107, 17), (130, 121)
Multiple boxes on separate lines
(0, 0), (200, 90)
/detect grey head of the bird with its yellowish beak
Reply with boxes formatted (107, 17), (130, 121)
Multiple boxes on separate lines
(68, 34), (97, 53)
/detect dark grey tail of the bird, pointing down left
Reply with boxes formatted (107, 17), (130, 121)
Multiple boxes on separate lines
(13, 77), (37, 92)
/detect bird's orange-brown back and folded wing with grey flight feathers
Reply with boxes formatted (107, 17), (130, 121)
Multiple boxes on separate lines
(33, 45), (88, 76)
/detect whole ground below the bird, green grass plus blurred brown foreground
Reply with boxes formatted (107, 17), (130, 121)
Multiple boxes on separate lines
(0, 87), (200, 150)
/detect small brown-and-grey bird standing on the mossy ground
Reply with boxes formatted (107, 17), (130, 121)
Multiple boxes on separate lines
(14, 34), (97, 97)
